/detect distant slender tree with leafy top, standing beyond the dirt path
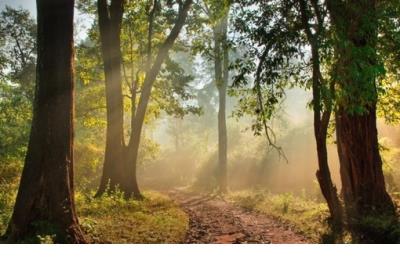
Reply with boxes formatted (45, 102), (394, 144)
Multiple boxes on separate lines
(191, 0), (231, 193)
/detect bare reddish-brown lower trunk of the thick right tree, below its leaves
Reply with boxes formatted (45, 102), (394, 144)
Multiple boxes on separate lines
(336, 106), (394, 218)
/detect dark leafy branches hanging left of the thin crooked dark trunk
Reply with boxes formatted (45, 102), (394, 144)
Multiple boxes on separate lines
(230, 1), (304, 157)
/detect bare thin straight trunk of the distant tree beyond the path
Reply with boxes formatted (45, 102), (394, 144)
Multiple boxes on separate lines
(213, 14), (229, 193)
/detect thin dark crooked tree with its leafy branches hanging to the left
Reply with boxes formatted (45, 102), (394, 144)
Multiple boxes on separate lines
(231, 0), (342, 225)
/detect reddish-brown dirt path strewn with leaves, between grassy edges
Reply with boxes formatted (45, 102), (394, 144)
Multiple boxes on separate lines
(169, 190), (307, 244)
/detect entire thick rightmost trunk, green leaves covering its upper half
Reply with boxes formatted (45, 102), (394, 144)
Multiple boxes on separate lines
(327, 0), (395, 220)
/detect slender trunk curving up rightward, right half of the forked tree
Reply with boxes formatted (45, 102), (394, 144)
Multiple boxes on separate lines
(126, 0), (193, 198)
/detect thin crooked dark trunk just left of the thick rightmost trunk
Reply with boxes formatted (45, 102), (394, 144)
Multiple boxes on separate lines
(299, 0), (343, 225)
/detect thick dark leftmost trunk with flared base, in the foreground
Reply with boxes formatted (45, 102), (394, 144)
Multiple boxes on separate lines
(7, 0), (85, 243)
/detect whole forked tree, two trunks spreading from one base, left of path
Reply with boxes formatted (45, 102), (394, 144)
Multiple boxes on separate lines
(97, 0), (192, 198)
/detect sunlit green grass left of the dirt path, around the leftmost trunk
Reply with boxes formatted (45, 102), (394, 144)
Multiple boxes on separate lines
(0, 183), (189, 243)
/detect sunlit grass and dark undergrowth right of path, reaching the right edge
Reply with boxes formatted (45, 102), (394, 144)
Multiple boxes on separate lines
(228, 190), (400, 243)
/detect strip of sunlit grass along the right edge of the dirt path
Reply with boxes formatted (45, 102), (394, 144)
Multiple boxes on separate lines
(228, 190), (349, 243)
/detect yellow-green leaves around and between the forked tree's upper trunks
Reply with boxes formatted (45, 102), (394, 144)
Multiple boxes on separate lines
(77, 1), (200, 127)
